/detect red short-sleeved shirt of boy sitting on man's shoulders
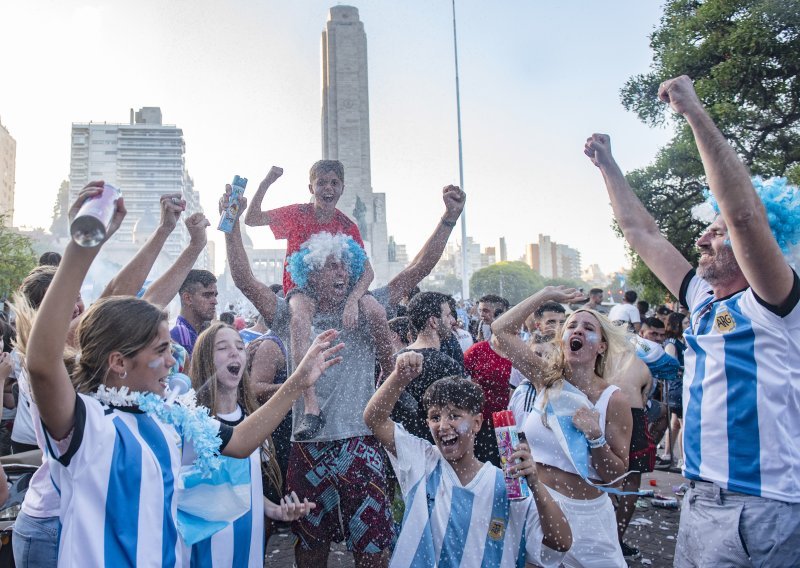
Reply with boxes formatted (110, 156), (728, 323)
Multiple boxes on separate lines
(267, 203), (364, 294)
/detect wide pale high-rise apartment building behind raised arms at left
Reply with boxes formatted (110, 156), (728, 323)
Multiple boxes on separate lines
(69, 107), (208, 268)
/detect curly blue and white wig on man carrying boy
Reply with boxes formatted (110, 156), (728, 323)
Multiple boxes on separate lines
(287, 232), (367, 288)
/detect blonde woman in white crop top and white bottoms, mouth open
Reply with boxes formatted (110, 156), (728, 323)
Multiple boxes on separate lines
(492, 286), (632, 567)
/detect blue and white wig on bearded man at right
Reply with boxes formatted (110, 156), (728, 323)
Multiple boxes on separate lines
(692, 176), (800, 270)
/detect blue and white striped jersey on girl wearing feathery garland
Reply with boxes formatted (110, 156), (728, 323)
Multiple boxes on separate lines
(46, 394), (230, 568)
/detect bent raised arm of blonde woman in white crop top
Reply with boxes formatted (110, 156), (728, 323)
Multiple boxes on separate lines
(492, 286), (583, 391)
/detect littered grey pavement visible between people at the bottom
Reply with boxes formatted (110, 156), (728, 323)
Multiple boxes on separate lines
(266, 471), (686, 568)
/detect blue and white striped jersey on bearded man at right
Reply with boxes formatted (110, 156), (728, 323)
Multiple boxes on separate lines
(680, 271), (800, 503)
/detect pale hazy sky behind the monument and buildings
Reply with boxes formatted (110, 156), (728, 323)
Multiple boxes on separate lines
(0, 0), (671, 272)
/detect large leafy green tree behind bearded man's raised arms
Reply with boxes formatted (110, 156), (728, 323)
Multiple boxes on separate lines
(621, 0), (800, 298)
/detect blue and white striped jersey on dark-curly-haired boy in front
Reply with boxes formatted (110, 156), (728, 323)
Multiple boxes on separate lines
(382, 425), (564, 568)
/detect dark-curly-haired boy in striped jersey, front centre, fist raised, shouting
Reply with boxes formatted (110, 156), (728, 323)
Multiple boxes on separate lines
(364, 352), (572, 568)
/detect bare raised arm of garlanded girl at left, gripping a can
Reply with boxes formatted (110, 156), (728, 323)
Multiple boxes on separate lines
(26, 181), (126, 439)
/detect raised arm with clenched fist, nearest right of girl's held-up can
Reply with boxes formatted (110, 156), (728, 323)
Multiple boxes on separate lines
(100, 193), (186, 298)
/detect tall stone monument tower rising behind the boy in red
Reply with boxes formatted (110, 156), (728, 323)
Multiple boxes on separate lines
(322, 6), (389, 284)
